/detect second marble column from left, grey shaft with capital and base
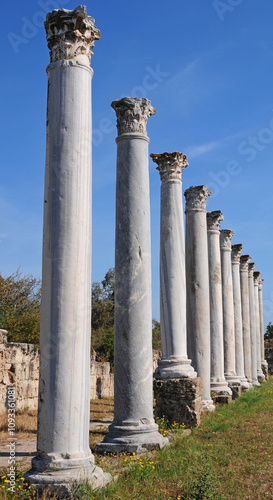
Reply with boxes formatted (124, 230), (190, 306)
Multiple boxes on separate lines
(97, 97), (166, 452)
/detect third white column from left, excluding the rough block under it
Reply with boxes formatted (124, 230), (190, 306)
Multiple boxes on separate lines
(151, 152), (197, 379)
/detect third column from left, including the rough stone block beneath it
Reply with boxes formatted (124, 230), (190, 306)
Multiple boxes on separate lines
(151, 152), (202, 427)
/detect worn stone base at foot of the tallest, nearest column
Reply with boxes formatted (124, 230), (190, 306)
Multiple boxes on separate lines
(24, 463), (112, 492)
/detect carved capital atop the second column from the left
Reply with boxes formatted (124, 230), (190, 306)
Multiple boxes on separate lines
(111, 97), (156, 136)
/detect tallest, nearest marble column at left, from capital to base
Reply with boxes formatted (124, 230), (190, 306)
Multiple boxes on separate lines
(25, 6), (109, 489)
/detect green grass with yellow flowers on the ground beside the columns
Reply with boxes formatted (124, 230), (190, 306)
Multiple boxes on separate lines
(0, 377), (273, 500)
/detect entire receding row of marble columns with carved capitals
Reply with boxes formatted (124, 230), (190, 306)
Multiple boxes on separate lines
(25, 6), (263, 489)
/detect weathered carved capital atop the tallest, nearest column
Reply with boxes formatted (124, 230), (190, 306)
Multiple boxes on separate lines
(45, 5), (101, 66)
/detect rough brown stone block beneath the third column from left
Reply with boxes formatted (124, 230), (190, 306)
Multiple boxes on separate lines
(154, 377), (203, 429)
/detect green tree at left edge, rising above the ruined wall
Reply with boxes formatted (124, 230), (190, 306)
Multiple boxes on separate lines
(0, 270), (41, 344)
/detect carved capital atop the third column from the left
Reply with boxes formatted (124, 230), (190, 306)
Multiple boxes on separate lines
(150, 152), (188, 182)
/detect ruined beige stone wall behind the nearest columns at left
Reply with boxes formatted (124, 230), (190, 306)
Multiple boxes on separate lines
(0, 330), (114, 413)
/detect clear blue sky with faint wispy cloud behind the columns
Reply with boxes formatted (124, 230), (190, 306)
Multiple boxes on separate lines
(0, 0), (273, 325)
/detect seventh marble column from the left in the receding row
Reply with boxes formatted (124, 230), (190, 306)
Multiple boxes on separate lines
(231, 244), (250, 391)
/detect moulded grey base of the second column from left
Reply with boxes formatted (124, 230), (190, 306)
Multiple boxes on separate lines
(96, 423), (169, 453)
